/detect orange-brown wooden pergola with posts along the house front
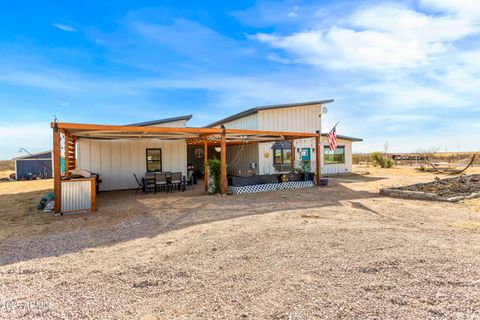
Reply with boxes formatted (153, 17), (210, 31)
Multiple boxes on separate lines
(51, 122), (320, 212)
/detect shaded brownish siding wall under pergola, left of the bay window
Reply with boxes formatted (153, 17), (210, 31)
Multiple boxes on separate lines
(227, 143), (258, 176)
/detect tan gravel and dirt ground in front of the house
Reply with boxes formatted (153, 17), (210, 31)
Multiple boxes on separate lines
(0, 166), (480, 319)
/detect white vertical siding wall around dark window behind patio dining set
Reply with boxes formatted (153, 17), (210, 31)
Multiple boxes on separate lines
(77, 139), (187, 191)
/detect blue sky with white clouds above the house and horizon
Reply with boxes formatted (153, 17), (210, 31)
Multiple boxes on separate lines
(0, 0), (480, 159)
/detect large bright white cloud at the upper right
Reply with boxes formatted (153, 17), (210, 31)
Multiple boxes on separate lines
(253, 4), (480, 70)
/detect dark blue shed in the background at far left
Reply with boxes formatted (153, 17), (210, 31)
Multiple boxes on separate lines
(14, 151), (65, 180)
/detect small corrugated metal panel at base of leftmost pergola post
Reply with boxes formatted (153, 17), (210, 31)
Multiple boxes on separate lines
(62, 180), (92, 212)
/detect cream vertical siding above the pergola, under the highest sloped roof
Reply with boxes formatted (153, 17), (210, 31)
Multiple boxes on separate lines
(258, 105), (321, 132)
